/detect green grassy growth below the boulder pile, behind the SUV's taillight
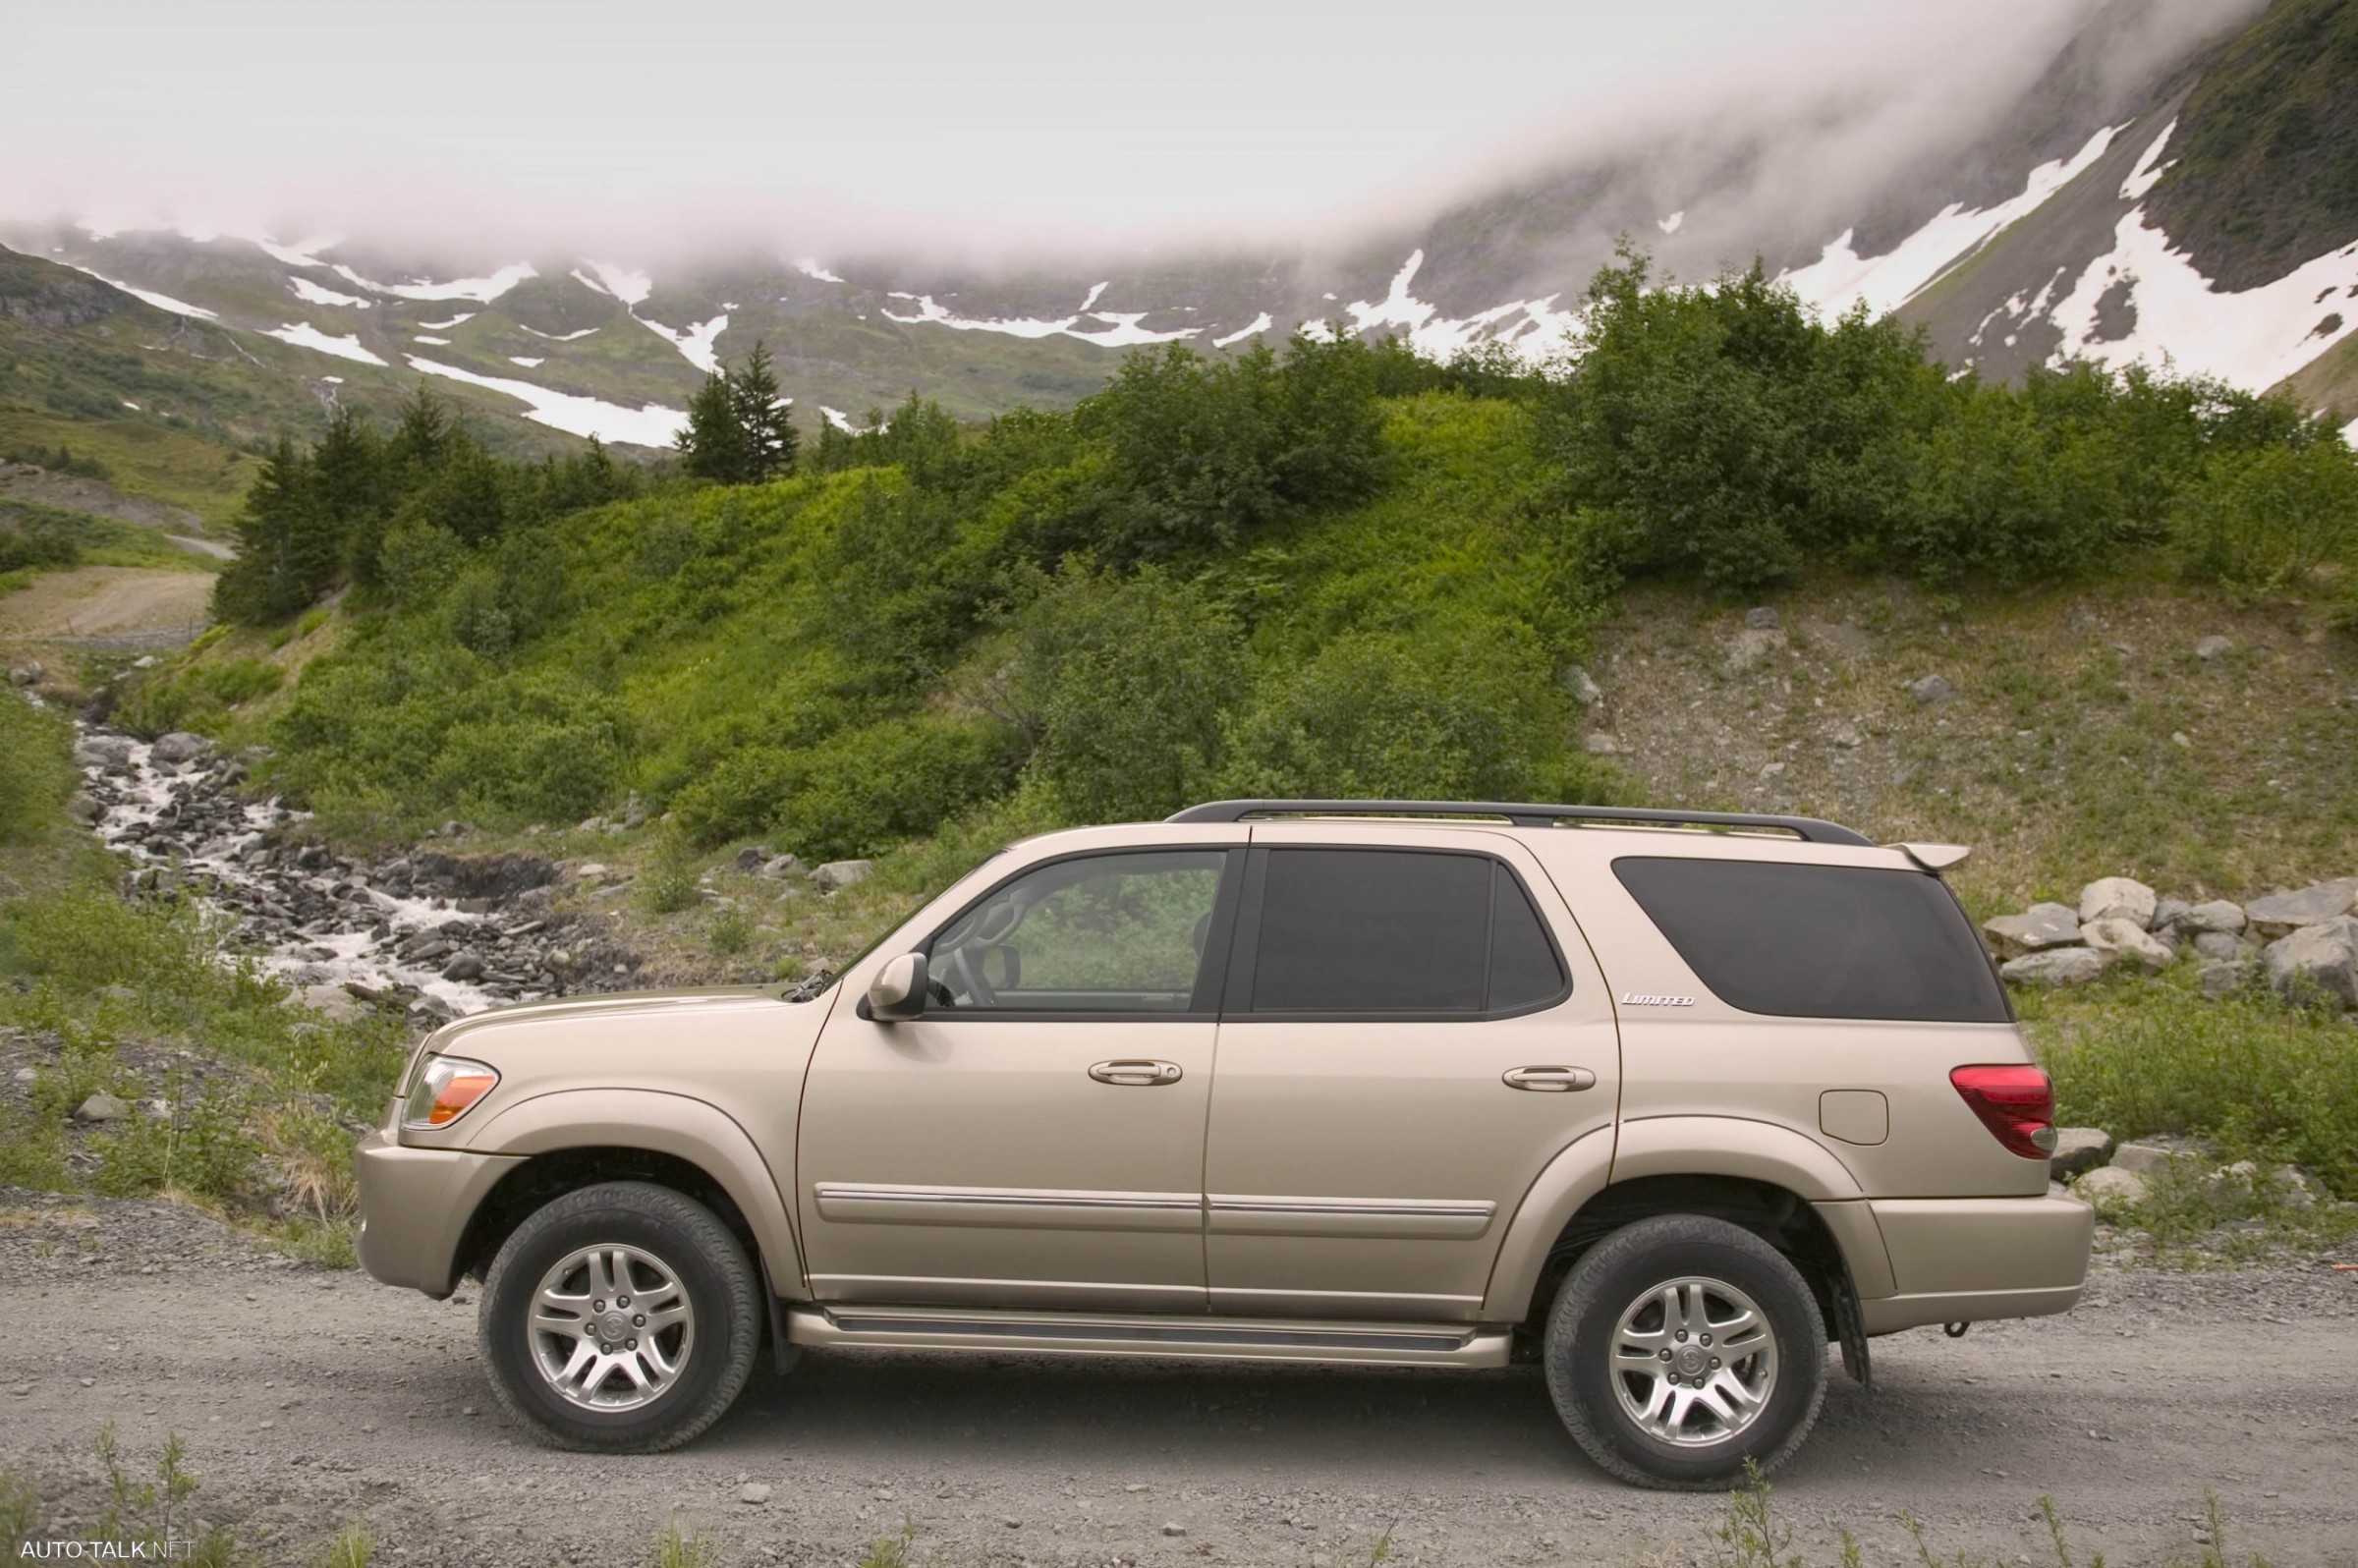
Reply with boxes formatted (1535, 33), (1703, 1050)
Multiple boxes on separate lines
(2035, 985), (2358, 1201)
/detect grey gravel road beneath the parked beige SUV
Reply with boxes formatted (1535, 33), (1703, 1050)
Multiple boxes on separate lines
(0, 1193), (2358, 1568)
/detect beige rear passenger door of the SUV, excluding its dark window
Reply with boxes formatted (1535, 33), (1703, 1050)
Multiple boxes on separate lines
(1205, 825), (1620, 1320)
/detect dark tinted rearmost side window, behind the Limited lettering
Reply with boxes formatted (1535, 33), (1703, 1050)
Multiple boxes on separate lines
(1613, 856), (2009, 1024)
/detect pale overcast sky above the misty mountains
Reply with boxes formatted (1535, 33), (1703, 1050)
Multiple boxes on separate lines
(0, 0), (2082, 253)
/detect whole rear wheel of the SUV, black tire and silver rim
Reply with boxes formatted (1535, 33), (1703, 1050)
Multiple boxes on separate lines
(1544, 1214), (1825, 1490)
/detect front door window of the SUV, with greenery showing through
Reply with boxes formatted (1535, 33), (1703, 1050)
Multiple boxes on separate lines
(926, 849), (1228, 1014)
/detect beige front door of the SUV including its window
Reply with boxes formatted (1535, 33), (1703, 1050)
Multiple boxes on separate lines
(797, 830), (1243, 1311)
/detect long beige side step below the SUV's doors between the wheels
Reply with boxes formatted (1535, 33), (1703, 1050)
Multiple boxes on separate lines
(785, 1304), (1511, 1368)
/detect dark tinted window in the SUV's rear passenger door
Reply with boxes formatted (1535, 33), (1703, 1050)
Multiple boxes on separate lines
(1250, 849), (1563, 1019)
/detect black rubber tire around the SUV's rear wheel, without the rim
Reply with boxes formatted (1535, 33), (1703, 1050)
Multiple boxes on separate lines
(1543, 1214), (1825, 1492)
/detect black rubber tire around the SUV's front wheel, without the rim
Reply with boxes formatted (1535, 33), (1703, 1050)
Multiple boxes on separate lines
(477, 1181), (761, 1452)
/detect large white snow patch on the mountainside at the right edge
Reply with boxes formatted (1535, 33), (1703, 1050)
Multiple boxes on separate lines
(2051, 207), (2358, 391)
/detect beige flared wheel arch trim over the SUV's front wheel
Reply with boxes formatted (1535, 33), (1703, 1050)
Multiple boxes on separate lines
(467, 1090), (809, 1299)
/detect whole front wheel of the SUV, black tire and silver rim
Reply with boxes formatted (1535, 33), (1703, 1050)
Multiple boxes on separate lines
(477, 1181), (761, 1452)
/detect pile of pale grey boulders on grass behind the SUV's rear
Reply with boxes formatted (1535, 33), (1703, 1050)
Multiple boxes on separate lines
(1981, 877), (2358, 1009)
